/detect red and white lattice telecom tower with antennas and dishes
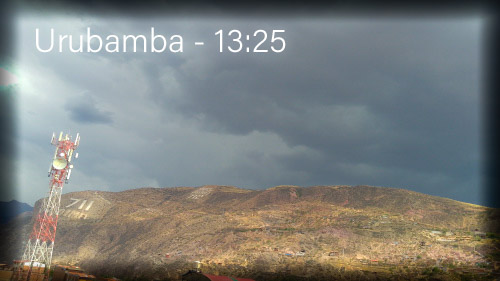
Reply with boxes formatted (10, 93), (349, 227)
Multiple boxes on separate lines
(18, 132), (80, 276)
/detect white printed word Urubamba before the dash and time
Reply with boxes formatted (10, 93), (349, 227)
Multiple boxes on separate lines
(36, 27), (183, 53)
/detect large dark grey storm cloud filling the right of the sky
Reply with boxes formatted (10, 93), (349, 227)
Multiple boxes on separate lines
(151, 20), (480, 200)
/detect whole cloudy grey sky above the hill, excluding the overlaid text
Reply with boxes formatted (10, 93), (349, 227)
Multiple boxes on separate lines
(6, 13), (485, 204)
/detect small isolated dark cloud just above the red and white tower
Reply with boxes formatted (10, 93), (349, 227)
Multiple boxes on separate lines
(65, 96), (113, 124)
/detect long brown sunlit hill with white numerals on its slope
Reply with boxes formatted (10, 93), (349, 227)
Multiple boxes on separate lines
(0, 186), (499, 280)
